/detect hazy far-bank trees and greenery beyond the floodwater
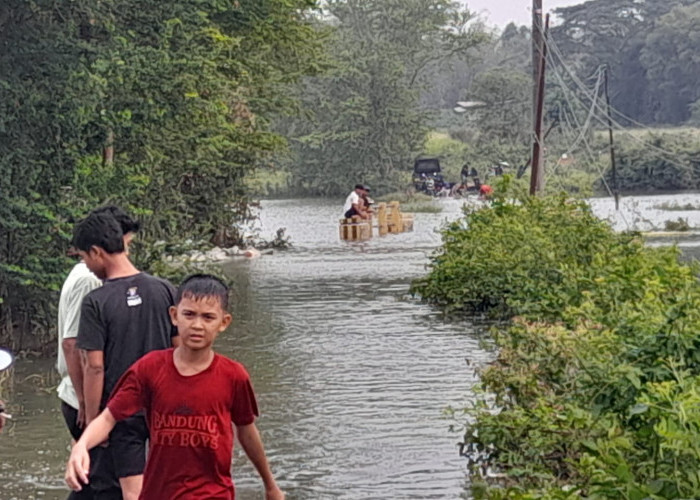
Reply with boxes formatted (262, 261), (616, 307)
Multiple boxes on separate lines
(258, 0), (700, 196)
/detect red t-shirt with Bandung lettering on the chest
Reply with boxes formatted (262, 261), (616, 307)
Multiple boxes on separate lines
(107, 349), (258, 500)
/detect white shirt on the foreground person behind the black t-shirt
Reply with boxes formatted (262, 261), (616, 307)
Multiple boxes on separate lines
(56, 262), (102, 410)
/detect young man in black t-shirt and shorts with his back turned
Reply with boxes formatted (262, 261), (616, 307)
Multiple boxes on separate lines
(73, 213), (177, 500)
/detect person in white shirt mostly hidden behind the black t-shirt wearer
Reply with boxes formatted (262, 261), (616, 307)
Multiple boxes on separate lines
(56, 205), (139, 500)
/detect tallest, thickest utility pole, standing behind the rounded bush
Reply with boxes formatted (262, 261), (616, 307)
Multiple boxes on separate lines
(530, 11), (549, 196)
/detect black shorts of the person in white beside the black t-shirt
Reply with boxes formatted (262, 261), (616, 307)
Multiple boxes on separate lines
(61, 401), (122, 500)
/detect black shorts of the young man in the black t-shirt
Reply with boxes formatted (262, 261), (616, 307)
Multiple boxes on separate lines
(108, 414), (148, 477)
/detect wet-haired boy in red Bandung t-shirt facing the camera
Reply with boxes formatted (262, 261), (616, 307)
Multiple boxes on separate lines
(66, 274), (284, 500)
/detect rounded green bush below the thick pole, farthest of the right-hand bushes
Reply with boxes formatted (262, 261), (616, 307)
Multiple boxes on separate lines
(413, 179), (630, 315)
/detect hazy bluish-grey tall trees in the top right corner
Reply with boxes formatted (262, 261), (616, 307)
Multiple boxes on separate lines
(551, 0), (700, 124)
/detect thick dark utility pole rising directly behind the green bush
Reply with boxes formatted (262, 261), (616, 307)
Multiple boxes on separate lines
(530, 4), (549, 195)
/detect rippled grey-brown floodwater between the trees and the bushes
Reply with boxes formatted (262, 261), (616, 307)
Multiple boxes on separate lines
(0, 194), (700, 500)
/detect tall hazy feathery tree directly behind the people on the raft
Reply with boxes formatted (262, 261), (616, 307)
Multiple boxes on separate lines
(282, 0), (481, 195)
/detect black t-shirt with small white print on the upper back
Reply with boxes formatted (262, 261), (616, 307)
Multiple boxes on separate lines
(77, 273), (177, 408)
